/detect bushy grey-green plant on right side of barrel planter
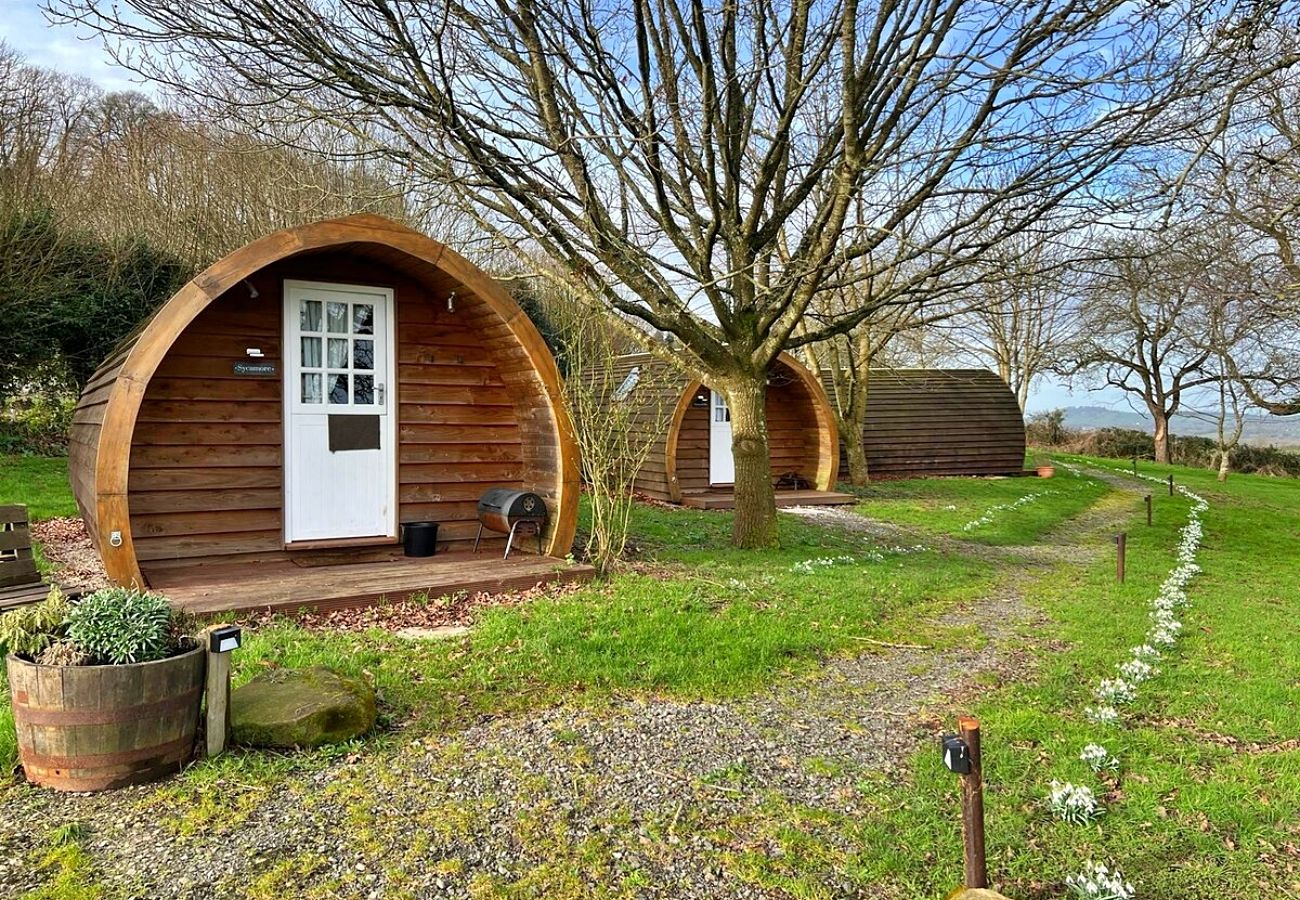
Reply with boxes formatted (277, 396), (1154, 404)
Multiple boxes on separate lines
(68, 588), (176, 666)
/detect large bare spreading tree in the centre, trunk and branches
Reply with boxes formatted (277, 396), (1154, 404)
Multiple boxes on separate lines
(52, 0), (1248, 546)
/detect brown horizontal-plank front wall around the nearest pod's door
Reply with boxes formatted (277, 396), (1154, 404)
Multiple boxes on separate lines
(122, 256), (524, 570)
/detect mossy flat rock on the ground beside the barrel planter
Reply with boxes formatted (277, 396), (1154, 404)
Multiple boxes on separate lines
(230, 666), (374, 748)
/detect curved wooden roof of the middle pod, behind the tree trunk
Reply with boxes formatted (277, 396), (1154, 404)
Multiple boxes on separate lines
(612, 352), (840, 503)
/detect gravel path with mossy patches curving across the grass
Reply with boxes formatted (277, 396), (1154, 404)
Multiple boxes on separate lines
(0, 486), (1131, 899)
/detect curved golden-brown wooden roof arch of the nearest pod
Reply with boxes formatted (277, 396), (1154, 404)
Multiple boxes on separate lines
(69, 215), (580, 585)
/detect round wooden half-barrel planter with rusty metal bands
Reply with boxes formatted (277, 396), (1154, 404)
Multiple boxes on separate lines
(8, 646), (207, 791)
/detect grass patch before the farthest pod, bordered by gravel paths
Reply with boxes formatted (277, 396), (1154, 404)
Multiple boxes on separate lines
(841, 468), (1106, 546)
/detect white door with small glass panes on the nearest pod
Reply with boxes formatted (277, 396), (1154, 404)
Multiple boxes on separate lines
(283, 281), (397, 544)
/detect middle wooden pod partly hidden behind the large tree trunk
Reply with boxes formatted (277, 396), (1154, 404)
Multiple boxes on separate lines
(612, 354), (853, 510)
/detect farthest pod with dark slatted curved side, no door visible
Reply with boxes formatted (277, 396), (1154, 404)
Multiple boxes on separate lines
(824, 369), (1024, 477)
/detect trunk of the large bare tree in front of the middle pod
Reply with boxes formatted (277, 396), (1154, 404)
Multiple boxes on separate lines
(722, 375), (776, 548)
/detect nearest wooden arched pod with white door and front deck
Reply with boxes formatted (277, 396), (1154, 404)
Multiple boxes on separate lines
(69, 215), (579, 611)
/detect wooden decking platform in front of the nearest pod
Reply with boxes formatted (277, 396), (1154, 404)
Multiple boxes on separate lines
(150, 553), (594, 614)
